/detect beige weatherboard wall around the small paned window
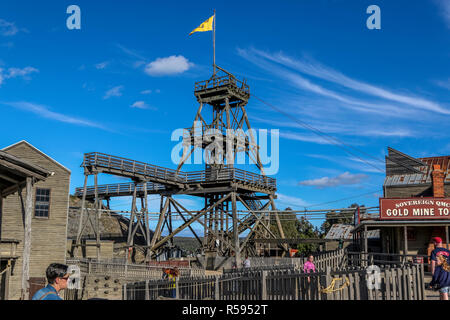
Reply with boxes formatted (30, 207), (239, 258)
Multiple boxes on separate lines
(0, 142), (70, 299)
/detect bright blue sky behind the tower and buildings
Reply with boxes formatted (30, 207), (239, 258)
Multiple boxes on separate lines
(0, 0), (450, 235)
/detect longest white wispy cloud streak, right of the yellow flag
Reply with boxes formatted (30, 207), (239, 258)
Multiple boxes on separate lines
(251, 48), (450, 114)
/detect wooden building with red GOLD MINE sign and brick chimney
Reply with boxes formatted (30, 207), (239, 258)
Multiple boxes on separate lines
(353, 148), (450, 261)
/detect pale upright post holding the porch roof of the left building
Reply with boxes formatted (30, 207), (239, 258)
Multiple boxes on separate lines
(22, 177), (33, 300)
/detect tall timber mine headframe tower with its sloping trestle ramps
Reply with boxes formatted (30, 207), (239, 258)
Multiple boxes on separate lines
(75, 66), (288, 263)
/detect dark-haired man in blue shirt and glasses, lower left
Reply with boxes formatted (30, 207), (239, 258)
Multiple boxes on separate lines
(32, 263), (70, 300)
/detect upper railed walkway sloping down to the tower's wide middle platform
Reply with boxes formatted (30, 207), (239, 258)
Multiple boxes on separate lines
(81, 152), (276, 194)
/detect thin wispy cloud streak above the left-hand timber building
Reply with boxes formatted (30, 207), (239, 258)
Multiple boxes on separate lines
(1, 101), (106, 130)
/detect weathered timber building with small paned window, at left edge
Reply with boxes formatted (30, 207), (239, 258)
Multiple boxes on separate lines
(0, 141), (70, 299)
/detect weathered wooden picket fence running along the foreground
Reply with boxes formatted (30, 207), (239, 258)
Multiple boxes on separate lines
(123, 264), (426, 300)
